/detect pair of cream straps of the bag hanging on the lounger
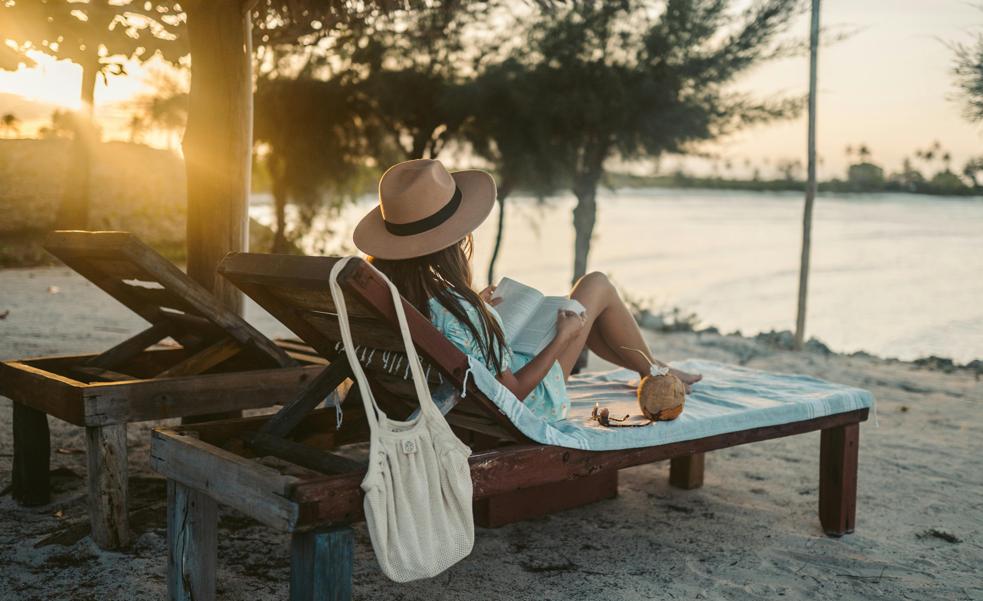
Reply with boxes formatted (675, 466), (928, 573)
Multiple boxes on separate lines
(328, 257), (440, 432)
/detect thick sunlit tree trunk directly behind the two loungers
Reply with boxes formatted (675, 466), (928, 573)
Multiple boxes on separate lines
(183, 0), (253, 313)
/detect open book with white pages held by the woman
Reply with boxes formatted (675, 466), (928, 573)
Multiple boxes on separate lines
(492, 278), (586, 355)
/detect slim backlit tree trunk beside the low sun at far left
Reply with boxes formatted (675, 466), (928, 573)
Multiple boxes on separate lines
(55, 56), (99, 230)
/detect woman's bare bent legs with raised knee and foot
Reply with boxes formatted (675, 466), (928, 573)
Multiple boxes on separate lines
(559, 272), (700, 388)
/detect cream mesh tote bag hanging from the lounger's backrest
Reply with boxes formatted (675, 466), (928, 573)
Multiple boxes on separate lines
(330, 257), (474, 582)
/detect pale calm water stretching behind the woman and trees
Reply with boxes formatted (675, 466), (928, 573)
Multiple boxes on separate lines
(251, 189), (983, 361)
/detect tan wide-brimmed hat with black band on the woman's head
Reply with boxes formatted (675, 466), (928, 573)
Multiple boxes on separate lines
(353, 159), (495, 259)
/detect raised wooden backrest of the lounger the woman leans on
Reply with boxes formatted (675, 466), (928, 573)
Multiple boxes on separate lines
(218, 253), (523, 439)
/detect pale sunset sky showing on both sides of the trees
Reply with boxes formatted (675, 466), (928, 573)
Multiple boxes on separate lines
(0, 0), (983, 179)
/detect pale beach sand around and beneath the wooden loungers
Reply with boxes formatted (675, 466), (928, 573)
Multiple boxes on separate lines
(0, 268), (983, 601)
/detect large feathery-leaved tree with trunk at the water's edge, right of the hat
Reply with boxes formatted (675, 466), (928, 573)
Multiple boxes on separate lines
(496, 0), (801, 279)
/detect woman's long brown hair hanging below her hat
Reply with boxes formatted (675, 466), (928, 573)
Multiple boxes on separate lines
(369, 234), (507, 373)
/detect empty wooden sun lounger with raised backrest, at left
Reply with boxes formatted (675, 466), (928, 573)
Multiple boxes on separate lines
(0, 231), (327, 548)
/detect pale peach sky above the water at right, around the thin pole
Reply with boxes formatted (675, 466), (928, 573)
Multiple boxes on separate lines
(714, 0), (983, 178)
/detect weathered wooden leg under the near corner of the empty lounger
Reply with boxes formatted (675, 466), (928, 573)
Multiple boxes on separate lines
(85, 424), (130, 549)
